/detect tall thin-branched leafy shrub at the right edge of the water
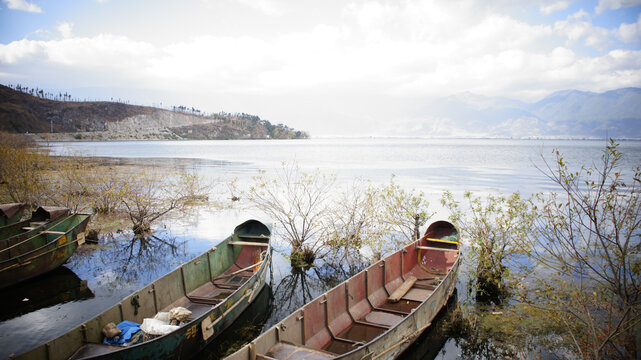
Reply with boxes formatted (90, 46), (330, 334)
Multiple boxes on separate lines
(527, 140), (641, 359)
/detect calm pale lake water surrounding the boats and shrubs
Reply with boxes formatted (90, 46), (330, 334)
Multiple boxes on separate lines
(0, 139), (641, 359)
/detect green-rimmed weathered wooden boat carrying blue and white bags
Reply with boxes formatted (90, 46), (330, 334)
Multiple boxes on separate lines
(17, 220), (271, 360)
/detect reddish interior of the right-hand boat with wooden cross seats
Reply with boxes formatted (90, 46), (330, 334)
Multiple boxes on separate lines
(238, 223), (458, 360)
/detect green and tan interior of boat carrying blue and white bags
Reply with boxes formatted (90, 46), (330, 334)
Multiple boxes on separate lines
(65, 229), (269, 359)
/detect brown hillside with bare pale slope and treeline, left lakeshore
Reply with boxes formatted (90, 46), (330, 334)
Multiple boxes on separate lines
(0, 85), (307, 140)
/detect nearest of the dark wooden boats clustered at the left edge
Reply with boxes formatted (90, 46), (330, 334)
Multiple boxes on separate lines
(0, 214), (90, 289)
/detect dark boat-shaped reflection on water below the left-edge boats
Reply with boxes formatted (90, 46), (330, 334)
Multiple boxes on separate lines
(0, 266), (94, 321)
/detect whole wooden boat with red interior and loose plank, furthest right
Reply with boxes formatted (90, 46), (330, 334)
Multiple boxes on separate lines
(227, 221), (459, 360)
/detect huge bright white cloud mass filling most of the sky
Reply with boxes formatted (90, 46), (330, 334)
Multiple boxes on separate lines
(0, 0), (641, 130)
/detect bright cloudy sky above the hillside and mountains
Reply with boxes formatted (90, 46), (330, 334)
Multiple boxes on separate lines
(0, 0), (641, 136)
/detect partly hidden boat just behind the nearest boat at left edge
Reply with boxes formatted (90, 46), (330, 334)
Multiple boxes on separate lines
(0, 206), (69, 249)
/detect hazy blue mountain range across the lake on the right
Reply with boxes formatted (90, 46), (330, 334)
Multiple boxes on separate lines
(408, 88), (641, 139)
